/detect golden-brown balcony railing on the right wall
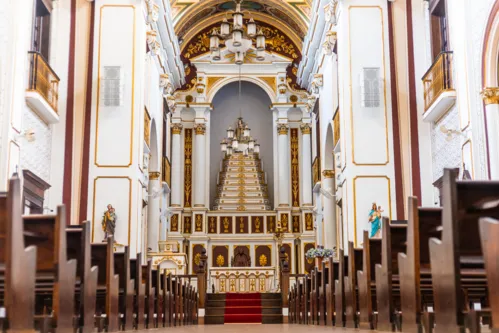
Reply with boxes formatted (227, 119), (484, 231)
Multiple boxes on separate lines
(422, 52), (454, 111)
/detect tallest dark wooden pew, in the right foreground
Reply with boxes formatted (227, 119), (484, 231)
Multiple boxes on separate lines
(430, 169), (499, 333)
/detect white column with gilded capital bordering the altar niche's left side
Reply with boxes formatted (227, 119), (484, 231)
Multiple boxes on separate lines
(193, 124), (206, 207)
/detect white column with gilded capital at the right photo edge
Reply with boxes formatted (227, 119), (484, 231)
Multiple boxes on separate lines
(482, 87), (499, 180)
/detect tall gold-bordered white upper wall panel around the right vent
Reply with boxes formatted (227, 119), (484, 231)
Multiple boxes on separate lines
(349, 6), (389, 165)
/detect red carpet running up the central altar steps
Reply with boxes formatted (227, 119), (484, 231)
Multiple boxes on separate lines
(224, 293), (262, 324)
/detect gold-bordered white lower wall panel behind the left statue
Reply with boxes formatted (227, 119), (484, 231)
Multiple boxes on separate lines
(92, 176), (132, 245)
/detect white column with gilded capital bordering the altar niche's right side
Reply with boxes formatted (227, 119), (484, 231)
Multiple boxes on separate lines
(277, 124), (291, 207)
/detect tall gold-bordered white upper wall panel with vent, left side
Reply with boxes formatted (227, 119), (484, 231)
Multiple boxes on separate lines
(94, 5), (136, 167)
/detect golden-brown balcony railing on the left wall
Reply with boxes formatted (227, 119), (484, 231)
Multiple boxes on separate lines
(28, 51), (60, 112)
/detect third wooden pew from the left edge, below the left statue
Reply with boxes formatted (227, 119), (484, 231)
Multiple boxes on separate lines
(66, 221), (98, 333)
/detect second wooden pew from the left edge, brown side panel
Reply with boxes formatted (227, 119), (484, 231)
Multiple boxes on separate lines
(23, 206), (76, 333)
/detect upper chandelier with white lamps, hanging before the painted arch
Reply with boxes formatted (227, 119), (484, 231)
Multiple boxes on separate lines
(210, 0), (265, 65)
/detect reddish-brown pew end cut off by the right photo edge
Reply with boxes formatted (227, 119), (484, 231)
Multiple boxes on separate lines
(480, 218), (499, 333)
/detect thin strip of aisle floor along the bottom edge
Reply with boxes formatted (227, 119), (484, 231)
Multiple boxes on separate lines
(147, 324), (373, 333)
